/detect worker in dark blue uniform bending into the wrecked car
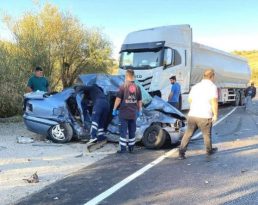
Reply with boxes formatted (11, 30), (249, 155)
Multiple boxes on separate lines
(84, 85), (110, 143)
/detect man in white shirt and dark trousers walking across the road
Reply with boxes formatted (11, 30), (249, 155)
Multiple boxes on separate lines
(179, 69), (218, 159)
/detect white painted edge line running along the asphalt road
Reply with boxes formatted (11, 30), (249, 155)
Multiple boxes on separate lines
(84, 107), (237, 205)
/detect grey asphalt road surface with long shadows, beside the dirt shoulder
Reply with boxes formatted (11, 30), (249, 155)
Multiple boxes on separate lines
(15, 102), (258, 205)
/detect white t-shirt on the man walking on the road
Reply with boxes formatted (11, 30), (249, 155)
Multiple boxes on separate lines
(188, 79), (218, 118)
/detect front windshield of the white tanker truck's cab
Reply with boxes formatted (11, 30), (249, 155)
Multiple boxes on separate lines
(119, 49), (162, 70)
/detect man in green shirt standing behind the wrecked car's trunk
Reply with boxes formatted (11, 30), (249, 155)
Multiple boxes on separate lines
(27, 66), (50, 92)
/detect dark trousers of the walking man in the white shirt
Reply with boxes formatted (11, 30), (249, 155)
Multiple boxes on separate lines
(179, 117), (212, 154)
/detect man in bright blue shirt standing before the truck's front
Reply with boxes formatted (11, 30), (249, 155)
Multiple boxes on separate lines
(168, 76), (181, 109)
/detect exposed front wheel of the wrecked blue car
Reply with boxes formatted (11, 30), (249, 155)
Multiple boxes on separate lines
(142, 125), (166, 149)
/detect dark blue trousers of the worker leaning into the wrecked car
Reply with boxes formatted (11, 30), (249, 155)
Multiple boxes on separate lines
(91, 99), (109, 140)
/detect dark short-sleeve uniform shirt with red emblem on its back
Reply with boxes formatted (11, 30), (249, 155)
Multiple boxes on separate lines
(117, 82), (142, 120)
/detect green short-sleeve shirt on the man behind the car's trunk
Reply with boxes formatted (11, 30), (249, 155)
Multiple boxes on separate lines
(27, 75), (49, 92)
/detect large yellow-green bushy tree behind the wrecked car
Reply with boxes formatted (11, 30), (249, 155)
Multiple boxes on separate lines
(0, 4), (114, 117)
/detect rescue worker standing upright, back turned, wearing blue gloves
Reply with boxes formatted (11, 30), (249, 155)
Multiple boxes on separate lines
(112, 69), (142, 153)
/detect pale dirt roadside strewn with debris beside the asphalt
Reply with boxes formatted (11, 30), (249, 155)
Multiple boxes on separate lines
(0, 122), (117, 204)
